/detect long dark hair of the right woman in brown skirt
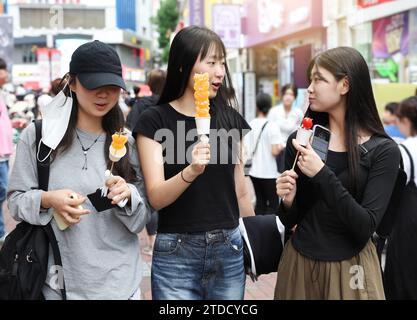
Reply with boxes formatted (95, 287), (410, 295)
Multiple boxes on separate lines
(306, 47), (389, 195)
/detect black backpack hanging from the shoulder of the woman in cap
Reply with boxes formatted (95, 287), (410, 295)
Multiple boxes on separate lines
(0, 120), (66, 300)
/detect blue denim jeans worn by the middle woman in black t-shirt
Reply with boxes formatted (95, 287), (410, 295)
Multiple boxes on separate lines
(151, 228), (246, 300)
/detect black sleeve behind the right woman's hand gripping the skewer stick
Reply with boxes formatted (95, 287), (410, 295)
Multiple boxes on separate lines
(278, 132), (302, 229)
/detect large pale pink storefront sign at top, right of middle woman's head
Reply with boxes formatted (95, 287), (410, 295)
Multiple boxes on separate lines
(245, 0), (323, 47)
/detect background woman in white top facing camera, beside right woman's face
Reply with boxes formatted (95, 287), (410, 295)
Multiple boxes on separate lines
(268, 83), (303, 173)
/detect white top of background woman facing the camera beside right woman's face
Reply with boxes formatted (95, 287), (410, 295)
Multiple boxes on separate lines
(268, 103), (304, 146)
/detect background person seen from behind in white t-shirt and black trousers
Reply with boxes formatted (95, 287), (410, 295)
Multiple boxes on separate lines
(245, 93), (283, 215)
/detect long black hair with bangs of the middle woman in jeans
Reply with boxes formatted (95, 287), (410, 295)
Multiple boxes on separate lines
(158, 26), (241, 130)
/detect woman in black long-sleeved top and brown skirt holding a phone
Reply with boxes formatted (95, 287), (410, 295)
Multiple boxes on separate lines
(275, 47), (400, 299)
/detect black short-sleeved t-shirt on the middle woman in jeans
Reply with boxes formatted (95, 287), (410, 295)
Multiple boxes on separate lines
(133, 104), (250, 233)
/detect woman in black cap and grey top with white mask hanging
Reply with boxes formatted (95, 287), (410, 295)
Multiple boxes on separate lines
(8, 41), (150, 299)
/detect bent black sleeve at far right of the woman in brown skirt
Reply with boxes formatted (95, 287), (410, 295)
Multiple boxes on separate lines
(311, 140), (400, 242)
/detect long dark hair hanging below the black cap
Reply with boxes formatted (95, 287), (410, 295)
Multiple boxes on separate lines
(52, 73), (134, 181)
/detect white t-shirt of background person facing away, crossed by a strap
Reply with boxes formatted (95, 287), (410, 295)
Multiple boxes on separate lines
(244, 118), (282, 179)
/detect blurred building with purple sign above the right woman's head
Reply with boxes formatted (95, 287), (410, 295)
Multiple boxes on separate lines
(323, 0), (417, 83)
